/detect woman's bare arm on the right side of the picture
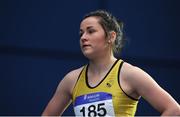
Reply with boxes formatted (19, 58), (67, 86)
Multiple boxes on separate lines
(123, 63), (180, 116)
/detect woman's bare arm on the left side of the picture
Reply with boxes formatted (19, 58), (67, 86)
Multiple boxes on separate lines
(42, 69), (81, 116)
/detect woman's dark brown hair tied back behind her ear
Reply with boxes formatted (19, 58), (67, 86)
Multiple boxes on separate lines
(83, 10), (125, 53)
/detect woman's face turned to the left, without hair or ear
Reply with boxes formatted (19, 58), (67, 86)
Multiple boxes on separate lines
(80, 16), (109, 58)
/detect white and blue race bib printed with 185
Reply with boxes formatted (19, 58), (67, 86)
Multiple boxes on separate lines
(74, 92), (115, 117)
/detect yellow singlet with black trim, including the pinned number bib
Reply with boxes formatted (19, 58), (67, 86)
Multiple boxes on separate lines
(73, 60), (138, 116)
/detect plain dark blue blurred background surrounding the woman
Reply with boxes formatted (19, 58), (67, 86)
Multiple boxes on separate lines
(0, 0), (180, 116)
